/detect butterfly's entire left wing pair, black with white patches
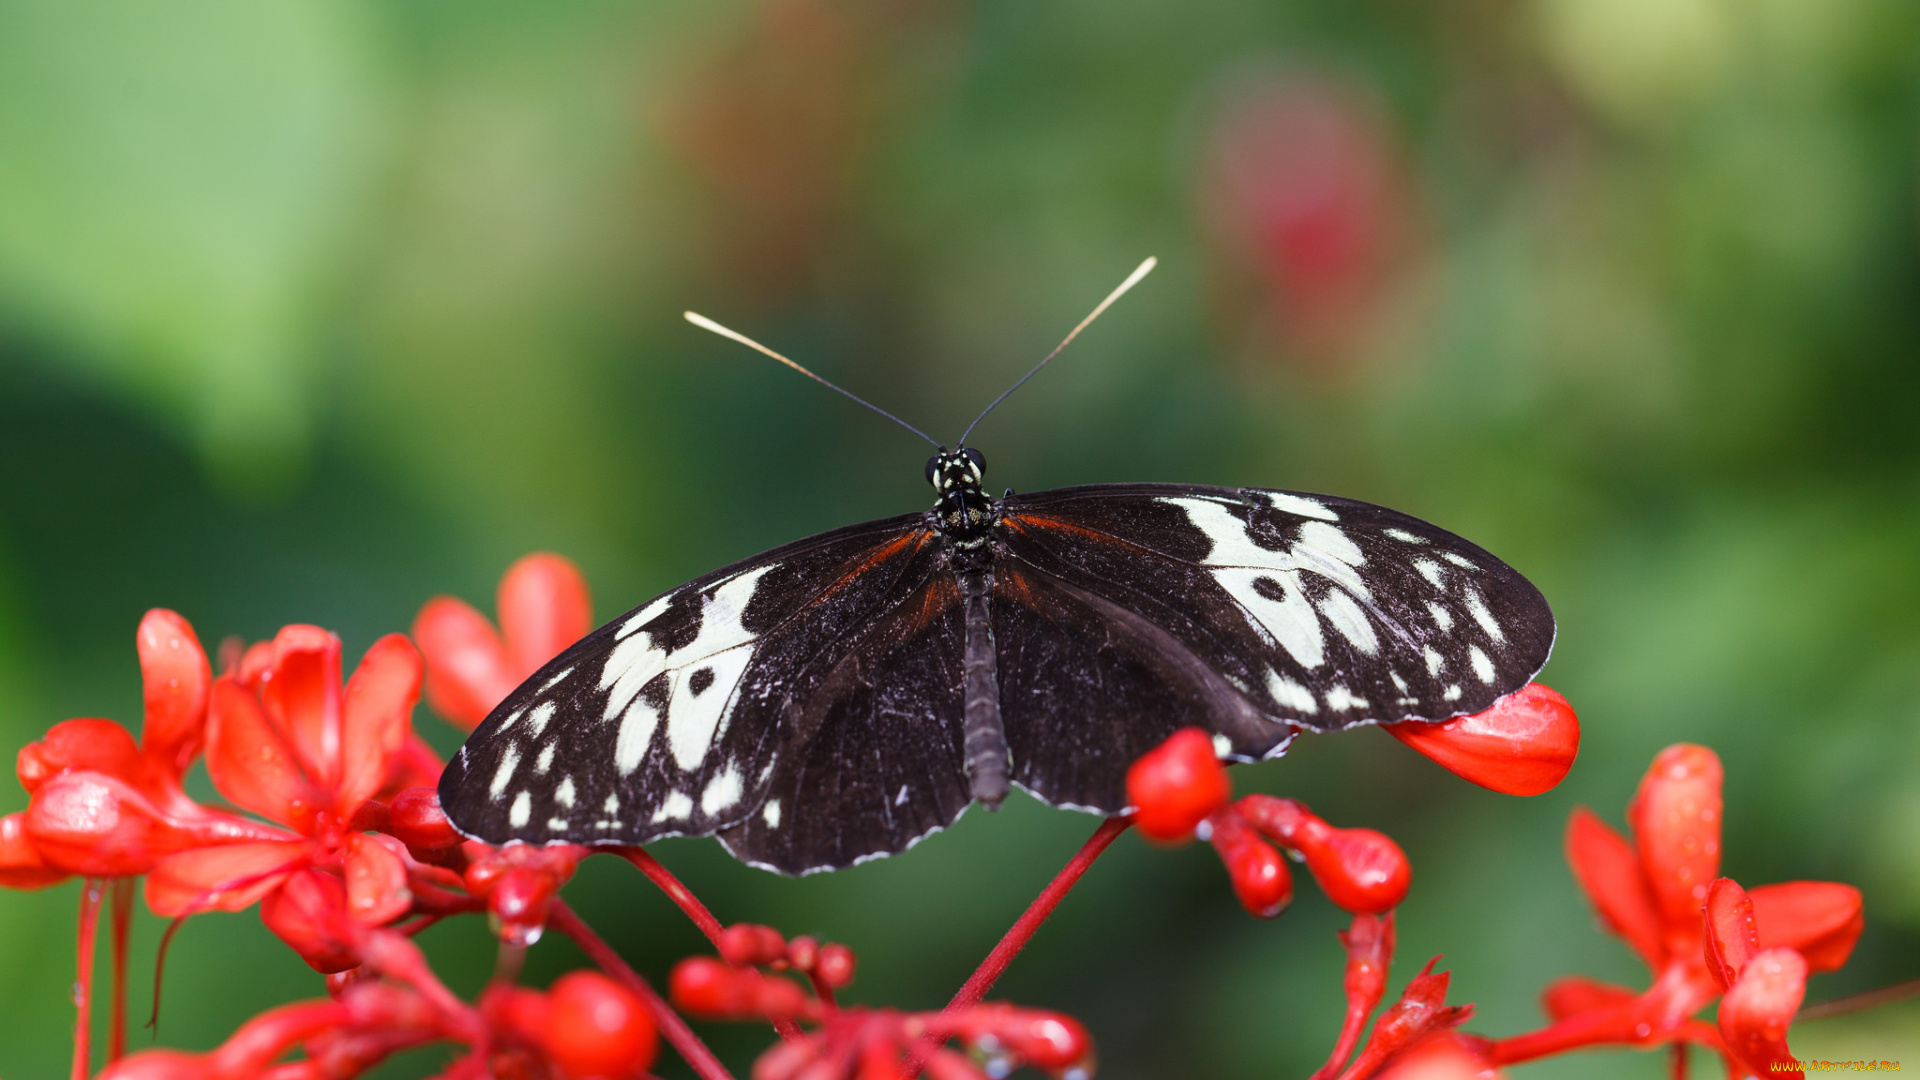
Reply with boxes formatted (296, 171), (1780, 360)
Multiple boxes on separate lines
(440, 513), (966, 872)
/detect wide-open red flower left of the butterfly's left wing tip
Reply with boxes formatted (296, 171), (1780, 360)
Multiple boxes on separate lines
(146, 625), (420, 970)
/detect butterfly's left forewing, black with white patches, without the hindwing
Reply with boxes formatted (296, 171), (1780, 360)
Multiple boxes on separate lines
(440, 515), (958, 844)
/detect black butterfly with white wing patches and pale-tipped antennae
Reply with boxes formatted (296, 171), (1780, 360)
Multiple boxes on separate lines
(440, 259), (1555, 874)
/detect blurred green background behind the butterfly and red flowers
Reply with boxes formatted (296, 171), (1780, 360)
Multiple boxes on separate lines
(0, 0), (1920, 1080)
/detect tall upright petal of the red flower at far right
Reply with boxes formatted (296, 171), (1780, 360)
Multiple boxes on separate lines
(1626, 742), (1722, 953)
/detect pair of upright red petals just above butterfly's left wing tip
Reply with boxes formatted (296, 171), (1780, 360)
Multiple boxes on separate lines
(413, 552), (593, 730)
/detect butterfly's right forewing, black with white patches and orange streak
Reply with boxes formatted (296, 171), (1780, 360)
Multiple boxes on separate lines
(1002, 484), (1553, 730)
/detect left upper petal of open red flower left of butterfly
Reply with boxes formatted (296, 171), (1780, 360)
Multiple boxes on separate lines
(207, 675), (326, 832)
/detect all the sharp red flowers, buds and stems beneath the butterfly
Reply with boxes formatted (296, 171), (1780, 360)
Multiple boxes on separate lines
(0, 555), (1862, 1080)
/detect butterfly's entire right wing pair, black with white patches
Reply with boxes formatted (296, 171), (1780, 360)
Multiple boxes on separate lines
(995, 484), (1553, 811)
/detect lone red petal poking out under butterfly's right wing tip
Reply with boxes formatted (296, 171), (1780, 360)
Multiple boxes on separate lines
(1384, 682), (1580, 796)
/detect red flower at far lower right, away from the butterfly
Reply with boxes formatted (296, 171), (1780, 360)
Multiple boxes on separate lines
(1494, 744), (1862, 1063)
